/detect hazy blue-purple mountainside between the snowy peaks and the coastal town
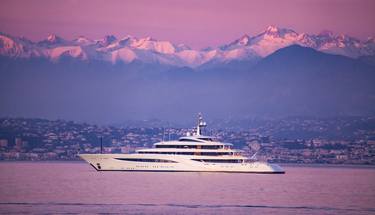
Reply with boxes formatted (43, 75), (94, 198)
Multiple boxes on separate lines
(0, 45), (375, 123)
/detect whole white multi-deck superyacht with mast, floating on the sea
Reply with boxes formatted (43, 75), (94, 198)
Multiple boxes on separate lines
(79, 115), (285, 174)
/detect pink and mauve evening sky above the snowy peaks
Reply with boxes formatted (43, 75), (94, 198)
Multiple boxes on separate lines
(0, 0), (375, 48)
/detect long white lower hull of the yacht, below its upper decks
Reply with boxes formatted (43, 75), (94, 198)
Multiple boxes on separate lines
(79, 154), (285, 174)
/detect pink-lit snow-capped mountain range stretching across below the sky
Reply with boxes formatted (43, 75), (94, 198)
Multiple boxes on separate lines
(0, 26), (375, 68)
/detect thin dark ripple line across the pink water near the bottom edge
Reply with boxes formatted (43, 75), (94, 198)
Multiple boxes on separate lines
(0, 202), (375, 212)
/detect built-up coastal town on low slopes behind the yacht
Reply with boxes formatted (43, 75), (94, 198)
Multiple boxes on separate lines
(0, 117), (375, 165)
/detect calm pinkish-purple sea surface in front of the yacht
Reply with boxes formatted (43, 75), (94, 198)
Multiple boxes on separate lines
(0, 162), (375, 214)
